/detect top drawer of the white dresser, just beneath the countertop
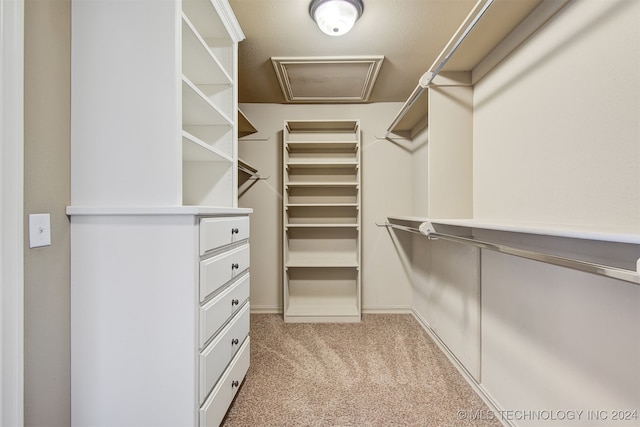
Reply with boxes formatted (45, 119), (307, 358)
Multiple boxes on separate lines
(200, 216), (249, 255)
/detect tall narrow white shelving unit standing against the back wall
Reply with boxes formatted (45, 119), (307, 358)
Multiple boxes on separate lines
(283, 120), (361, 322)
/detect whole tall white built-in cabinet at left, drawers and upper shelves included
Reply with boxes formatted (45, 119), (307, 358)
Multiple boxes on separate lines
(67, 0), (251, 426)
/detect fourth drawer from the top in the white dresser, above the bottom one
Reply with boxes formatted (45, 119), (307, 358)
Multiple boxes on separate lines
(199, 304), (249, 403)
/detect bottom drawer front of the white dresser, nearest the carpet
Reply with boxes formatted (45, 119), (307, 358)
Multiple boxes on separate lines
(200, 337), (250, 427)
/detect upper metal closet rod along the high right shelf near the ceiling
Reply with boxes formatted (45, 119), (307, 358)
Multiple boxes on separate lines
(385, 0), (494, 138)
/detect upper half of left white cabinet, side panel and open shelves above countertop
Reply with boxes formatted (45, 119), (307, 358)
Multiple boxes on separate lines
(71, 0), (244, 207)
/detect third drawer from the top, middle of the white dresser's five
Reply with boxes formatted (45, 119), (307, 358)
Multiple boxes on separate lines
(200, 273), (250, 348)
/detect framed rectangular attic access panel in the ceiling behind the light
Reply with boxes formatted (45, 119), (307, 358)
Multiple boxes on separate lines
(271, 56), (384, 103)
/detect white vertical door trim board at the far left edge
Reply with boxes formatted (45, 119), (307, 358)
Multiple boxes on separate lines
(0, 0), (24, 426)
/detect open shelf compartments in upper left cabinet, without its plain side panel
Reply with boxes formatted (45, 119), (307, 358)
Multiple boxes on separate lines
(181, 0), (238, 207)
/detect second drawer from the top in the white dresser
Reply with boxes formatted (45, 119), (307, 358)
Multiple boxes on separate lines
(200, 245), (249, 301)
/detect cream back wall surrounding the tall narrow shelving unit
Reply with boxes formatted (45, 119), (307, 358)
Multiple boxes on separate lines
(239, 103), (412, 312)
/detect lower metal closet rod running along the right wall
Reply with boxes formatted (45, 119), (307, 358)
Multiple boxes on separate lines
(378, 222), (640, 285)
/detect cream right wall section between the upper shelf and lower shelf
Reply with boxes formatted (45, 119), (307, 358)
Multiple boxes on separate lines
(473, 0), (640, 227)
